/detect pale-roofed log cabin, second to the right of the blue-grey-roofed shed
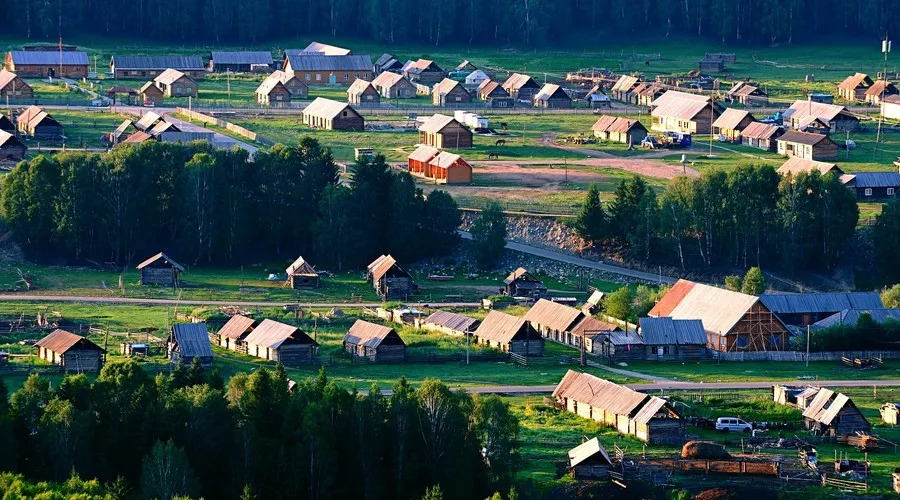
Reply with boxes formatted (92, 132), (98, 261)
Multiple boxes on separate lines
(242, 319), (319, 366)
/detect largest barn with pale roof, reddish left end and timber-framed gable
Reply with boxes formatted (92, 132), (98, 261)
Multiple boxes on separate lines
(647, 280), (789, 352)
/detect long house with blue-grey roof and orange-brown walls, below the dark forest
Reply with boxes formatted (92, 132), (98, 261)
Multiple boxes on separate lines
(282, 53), (372, 85)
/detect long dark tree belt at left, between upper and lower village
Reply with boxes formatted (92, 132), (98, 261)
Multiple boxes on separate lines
(0, 138), (460, 267)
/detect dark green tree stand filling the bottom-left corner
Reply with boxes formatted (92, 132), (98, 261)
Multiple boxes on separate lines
(0, 361), (519, 500)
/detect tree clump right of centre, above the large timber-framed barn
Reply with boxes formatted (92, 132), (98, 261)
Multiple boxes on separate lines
(576, 165), (859, 271)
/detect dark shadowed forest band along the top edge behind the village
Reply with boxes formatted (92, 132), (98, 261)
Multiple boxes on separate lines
(0, 0), (898, 46)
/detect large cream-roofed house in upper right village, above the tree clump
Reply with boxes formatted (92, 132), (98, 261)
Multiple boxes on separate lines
(650, 90), (720, 134)
